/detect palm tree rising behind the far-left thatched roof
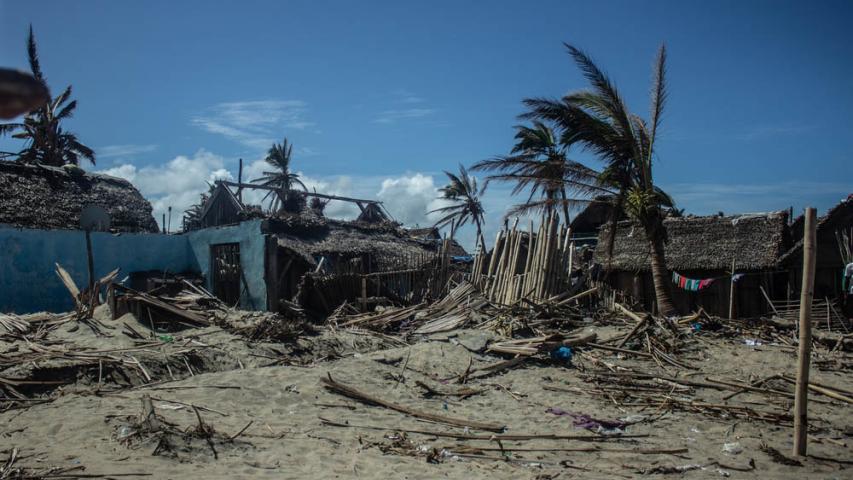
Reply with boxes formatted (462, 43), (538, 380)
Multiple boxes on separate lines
(0, 26), (95, 167)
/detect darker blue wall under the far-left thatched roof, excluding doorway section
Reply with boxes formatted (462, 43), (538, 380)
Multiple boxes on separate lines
(0, 225), (198, 313)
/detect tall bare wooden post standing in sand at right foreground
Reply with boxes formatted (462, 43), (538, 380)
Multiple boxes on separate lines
(794, 207), (817, 456)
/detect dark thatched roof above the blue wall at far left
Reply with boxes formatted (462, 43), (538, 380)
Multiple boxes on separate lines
(0, 162), (158, 232)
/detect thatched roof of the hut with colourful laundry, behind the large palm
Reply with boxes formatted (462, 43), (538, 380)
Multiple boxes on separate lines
(595, 211), (791, 271)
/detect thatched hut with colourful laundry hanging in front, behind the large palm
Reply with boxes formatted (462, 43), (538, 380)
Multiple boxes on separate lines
(595, 212), (791, 317)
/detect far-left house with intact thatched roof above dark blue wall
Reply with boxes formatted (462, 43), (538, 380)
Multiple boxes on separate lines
(0, 162), (188, 313)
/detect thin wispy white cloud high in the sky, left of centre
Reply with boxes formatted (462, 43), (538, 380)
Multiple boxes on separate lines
(191, 100), (316, 149)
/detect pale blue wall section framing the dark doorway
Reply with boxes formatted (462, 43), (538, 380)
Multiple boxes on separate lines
(186, 220), (267, 310)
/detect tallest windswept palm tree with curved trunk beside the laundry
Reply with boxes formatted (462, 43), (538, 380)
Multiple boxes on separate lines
(522, 44), (675, 315)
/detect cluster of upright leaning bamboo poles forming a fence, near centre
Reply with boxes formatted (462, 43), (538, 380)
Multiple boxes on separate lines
(471, 215), (575, 305)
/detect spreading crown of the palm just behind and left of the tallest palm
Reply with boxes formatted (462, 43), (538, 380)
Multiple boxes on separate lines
(471, 120), (607, 223)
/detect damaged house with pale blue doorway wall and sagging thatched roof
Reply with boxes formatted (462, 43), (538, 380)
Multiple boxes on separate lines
(181, 182), (464, 315)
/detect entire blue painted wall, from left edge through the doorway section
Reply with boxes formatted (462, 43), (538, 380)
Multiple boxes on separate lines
(0, 220), (267, 313)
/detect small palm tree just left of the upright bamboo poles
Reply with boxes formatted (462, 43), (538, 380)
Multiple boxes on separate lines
(429, 165), (486, 251)
